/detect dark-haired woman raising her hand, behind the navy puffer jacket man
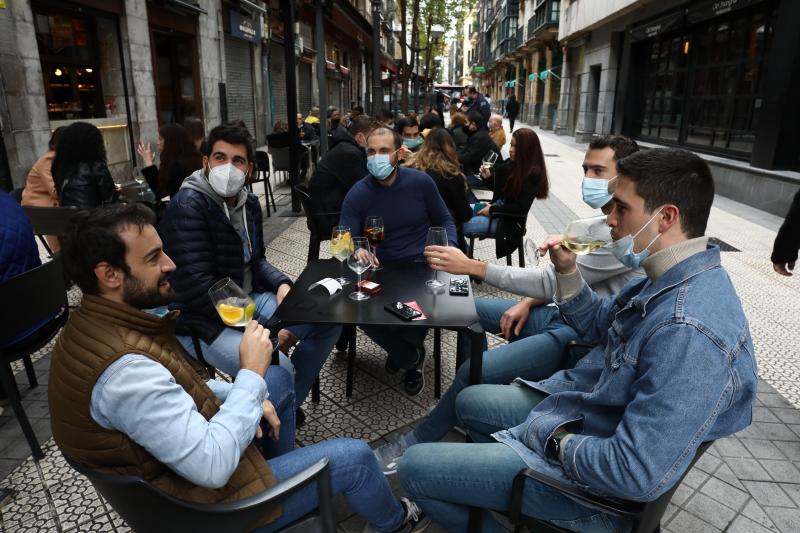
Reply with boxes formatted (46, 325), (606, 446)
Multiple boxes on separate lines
(136, 124), (203, 198)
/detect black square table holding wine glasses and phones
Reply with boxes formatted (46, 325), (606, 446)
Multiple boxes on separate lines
(270, 259), (483, 398)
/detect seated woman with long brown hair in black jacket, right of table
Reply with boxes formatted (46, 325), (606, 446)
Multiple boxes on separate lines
(464, 124), (550, 257)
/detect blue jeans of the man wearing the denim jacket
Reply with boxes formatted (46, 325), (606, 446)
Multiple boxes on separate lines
(398, 385), (624, 533)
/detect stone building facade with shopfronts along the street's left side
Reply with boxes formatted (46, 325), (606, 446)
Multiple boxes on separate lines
(0, 0), (396, 188)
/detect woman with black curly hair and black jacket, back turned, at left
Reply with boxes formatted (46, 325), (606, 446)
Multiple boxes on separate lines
(52, 122), (117, 209)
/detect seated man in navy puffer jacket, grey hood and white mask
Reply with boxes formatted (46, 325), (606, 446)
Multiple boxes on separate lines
(159, 125), (341, 422)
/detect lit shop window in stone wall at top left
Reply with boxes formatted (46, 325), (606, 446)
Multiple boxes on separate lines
(34, 12), (106, 120)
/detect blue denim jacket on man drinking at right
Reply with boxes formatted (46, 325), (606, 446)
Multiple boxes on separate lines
(495, 247), (757, 501)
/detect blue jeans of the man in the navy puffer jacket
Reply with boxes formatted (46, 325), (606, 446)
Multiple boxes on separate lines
(178, 292), (342, 405)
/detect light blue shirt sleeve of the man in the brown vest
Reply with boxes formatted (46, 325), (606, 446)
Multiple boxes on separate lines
(90, 354), (269, 489)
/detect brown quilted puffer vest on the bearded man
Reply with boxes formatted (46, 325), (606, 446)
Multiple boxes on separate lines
(48, 295), (281, 527)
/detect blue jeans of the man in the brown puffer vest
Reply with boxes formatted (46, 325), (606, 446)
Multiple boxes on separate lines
(256, 439), (405, 533)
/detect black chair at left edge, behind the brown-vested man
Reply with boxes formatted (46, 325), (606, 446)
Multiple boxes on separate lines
(0, 255), (69, 461)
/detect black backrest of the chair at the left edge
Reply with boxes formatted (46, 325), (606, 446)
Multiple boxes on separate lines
(0, 255), (68, 340)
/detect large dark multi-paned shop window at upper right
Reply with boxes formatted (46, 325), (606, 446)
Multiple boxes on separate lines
(638, 2), (774, 156)
